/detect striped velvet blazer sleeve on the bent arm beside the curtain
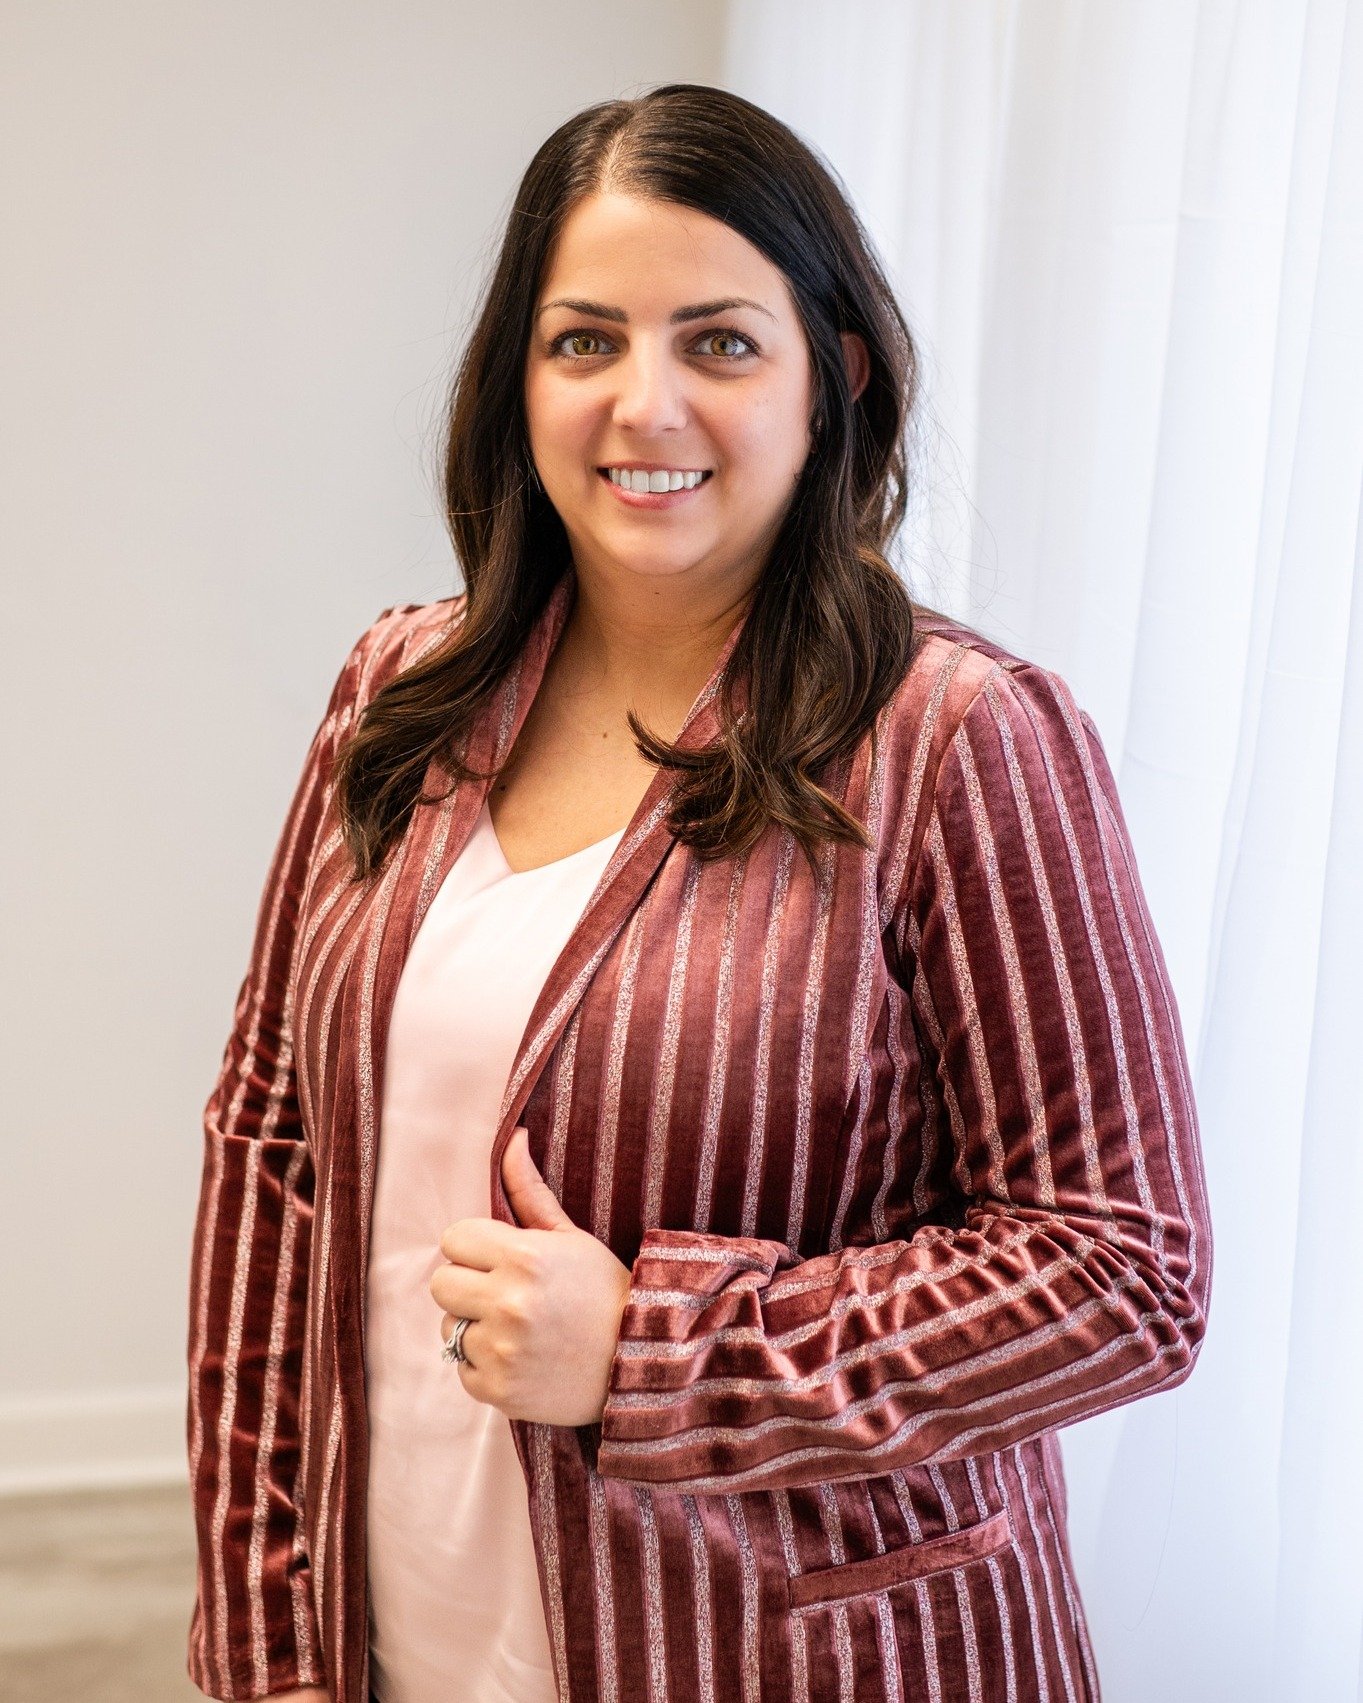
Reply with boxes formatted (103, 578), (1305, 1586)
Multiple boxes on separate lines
(596, 650), (1211, 1492)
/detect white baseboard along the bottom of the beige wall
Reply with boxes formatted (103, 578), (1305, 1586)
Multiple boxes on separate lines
(0, 1388), (189, 1495)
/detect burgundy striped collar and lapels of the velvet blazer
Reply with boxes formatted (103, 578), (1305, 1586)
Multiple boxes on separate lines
(371, 567), (746, 1224)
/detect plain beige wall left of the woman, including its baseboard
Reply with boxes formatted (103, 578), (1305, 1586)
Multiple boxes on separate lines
(0, 0), (722, 1487)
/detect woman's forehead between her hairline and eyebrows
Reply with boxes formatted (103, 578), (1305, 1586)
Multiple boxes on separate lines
(537, 192), (794, 320)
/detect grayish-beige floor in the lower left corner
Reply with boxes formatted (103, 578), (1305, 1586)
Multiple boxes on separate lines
(0, 1487), (203, 1703)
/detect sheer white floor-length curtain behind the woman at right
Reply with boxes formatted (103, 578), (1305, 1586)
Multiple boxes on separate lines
(724, 0), (1363, 1703)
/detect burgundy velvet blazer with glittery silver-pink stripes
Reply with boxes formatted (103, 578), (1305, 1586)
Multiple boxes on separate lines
(187, 569), (1211, 1703)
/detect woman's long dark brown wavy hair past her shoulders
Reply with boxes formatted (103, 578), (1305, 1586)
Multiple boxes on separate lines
(336, 83), (918, 879)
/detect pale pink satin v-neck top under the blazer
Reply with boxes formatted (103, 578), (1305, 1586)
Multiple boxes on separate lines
(365, 799), (624, 1703)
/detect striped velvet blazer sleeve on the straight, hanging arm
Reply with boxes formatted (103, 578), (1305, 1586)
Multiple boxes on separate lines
(186, 611), (378, 1698)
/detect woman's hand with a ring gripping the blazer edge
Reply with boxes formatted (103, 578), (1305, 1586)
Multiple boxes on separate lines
(431, 1124), (630, 1425)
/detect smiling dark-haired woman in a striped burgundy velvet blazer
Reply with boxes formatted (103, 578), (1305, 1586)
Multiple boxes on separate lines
(189, 85), (1211, 1703)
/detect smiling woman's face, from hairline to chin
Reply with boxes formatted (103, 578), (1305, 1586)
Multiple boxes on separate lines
(525, 192), (813, 596)
